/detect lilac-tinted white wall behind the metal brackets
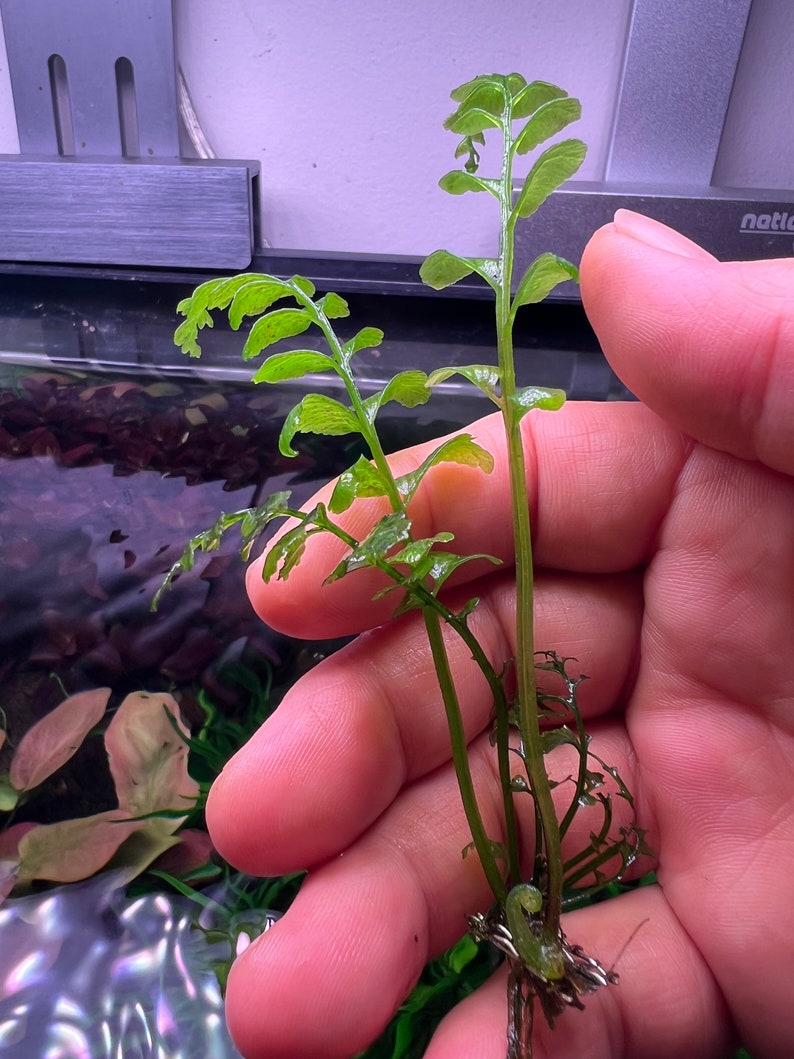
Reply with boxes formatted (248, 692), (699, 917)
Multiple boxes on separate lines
(0, 0), (794, 255)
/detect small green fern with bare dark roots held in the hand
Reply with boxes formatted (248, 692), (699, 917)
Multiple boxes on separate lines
(158, 73), (644, 1059)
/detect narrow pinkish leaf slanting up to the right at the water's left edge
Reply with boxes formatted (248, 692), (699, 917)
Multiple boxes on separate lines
(8, 687), (110, 791)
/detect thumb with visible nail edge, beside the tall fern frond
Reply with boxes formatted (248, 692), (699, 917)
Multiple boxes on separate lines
(581, 210), (794, 474)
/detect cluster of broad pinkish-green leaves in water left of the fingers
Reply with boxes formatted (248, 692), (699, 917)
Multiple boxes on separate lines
(0, 687), (211, 900)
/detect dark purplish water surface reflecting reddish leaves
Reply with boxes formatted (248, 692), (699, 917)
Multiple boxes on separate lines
(0, 355), (472, 812)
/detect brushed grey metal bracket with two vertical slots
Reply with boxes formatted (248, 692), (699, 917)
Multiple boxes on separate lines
(0, 0), (259, 269)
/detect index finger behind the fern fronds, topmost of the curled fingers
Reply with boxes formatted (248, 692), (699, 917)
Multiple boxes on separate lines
(248, 402), (689, 639)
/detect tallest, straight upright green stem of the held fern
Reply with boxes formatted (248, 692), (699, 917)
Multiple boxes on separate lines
(495, 105), (563, 936)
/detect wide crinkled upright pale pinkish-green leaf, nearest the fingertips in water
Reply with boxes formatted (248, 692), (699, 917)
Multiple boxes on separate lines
(105, 692), (199, 831)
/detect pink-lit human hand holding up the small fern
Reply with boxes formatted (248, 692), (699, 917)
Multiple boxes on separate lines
(207, 214), (794, 1059)
